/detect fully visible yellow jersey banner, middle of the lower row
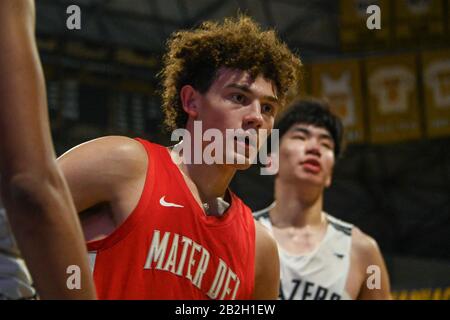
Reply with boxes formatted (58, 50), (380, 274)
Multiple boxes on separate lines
(366, 55), (421, 143)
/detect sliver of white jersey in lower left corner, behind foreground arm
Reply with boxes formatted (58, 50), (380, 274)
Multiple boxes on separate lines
(0, 192), (35, 300)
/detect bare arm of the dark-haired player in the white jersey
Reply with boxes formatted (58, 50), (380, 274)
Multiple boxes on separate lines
(355, 231), (391, 300)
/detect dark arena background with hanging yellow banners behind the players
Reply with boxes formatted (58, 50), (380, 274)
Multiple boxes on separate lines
(37, 0), (450, 299)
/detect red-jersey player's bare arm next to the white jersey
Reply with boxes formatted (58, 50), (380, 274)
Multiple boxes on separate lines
(253, 221), (280, 300)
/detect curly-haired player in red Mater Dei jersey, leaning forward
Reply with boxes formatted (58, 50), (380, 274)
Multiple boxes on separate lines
(59, 17), (301, 299)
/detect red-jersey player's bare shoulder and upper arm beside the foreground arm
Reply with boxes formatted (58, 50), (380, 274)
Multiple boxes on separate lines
(58, 136), (148, 220)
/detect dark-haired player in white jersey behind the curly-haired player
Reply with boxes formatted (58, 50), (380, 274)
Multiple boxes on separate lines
(255, 100), (390, 300)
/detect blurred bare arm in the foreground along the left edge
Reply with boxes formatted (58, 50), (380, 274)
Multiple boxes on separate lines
(0, 0), (95, 299)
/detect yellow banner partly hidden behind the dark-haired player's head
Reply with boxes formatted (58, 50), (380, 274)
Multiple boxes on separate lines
(312, 61), (365, 143)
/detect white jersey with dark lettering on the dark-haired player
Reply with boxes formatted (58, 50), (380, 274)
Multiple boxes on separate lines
(254, 203), (352, 300)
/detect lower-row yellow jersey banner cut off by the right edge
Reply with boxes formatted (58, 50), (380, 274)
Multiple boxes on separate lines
(422, 50), (450, 137)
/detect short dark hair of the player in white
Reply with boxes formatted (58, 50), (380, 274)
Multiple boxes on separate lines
(275, 99), (344, 158)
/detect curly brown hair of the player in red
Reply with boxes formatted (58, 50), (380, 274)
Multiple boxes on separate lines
(160, 15), (302, 130)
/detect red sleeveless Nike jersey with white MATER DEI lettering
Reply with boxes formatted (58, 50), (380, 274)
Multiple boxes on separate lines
(88, 139), (255, 299)
